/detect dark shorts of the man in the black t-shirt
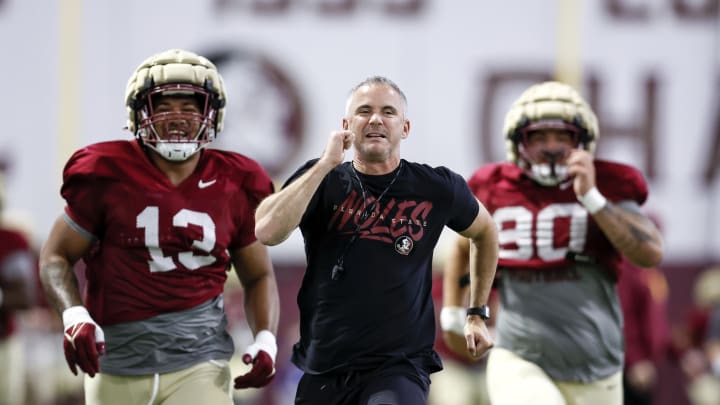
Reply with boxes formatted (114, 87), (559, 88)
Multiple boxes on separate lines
(295, 362), (430, 405)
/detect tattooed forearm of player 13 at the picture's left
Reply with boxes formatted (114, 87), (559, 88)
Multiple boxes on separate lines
(40, 255), (83, 314)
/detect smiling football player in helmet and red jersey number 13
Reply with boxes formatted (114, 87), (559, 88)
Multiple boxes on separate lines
(40, 49), (279, 405)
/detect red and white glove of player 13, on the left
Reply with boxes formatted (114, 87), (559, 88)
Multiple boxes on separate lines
(62, 306), (105, 377)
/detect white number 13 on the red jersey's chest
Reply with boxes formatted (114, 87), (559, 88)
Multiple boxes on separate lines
(137, 207), (216, 272)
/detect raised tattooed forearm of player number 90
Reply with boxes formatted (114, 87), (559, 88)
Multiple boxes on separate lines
(593, 203), (663, 267)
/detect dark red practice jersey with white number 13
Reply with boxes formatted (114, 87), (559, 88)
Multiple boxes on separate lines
(61, 141), (273, 325)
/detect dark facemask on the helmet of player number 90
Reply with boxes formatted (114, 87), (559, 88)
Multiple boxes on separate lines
(517, 120), (582, 186)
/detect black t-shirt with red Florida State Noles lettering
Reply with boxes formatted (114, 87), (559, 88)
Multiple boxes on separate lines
(285, 159), (479, 374)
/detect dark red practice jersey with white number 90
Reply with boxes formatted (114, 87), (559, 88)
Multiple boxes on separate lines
(468, 160), (648, 275)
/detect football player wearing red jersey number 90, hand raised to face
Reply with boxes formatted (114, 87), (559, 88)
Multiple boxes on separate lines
(441, 81), (663, 405)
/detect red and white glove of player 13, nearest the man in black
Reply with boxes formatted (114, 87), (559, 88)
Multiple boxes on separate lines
(235, 330), (277, 389)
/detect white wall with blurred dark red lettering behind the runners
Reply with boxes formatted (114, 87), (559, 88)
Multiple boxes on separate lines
(0, 0), (720, 261)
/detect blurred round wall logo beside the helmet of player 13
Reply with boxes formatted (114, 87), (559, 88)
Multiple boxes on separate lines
(207, 49), (304, 177)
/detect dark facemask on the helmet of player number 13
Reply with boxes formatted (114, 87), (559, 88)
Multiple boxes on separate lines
(137, 84), (217, 161)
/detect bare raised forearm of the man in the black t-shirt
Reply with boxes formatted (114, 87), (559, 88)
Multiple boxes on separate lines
(255, 161), (332, 246)
